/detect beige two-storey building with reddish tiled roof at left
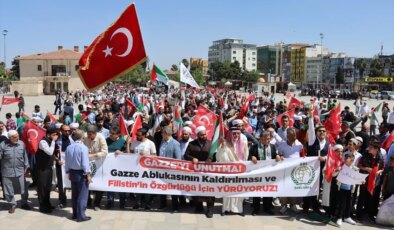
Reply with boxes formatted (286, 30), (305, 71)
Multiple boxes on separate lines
(12, 46), (85, 95)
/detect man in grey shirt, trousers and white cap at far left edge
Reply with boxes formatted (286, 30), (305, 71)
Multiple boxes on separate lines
(0, 130), (30, 214)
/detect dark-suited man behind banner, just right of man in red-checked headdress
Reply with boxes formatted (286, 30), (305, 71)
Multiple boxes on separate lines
(249, 131), (283, 216)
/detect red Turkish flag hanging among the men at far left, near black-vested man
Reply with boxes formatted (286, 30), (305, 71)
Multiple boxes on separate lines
(22, 121), (46, 154)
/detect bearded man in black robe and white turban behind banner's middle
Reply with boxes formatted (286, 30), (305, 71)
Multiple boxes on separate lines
(184, 126), (215, 218)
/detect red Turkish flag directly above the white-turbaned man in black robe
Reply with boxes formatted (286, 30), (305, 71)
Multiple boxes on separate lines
(192, 105), (217, 140)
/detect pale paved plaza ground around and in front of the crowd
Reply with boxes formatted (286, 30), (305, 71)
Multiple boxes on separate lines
(0, 91), (394, 230)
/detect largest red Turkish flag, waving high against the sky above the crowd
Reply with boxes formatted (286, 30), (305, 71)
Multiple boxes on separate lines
(78, 4), (146, 90)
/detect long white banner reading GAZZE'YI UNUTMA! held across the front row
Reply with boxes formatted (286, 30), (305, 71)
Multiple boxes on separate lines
(63, 153), (320, 197)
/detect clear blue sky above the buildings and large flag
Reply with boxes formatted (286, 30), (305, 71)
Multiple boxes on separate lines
(0, 0), (394, 69)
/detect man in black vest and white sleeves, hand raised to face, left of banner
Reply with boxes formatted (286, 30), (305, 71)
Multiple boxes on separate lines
(35, 128), (58, 213)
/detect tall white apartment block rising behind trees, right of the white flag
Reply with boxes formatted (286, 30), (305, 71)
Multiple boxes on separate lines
(208, 38), (257, 71)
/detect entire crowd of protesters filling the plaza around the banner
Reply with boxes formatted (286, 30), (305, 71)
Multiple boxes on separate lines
(0, 85), (394, 225)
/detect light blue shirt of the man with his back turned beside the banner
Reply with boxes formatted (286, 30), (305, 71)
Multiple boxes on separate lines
(65, 141), (90, 174)
